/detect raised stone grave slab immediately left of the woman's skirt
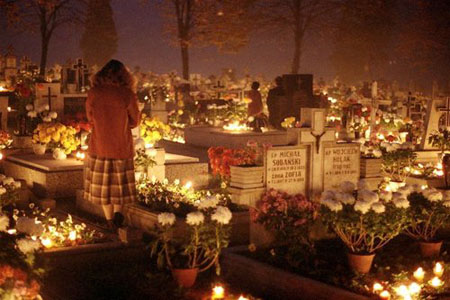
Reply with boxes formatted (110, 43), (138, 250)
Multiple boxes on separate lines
(3, 154), (83, 198)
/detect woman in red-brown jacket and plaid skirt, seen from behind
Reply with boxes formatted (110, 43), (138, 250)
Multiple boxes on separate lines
(84, 60), (140, 229)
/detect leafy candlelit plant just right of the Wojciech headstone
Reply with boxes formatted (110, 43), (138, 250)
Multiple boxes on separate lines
(381, 143), (417, 191)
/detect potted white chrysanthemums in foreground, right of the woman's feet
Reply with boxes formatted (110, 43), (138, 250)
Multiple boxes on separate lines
(151, 206), (232, 288)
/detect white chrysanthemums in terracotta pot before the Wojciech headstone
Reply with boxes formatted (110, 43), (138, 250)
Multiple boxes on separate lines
(321, 182), (409, 273)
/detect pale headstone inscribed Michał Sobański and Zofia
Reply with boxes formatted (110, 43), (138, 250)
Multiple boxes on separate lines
(265, 146), (309, 194)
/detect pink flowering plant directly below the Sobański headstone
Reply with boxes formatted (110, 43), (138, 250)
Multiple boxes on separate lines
(252, 189), (318, 252)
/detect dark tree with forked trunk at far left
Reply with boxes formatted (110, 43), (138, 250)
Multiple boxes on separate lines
(0, 0), (85, 76)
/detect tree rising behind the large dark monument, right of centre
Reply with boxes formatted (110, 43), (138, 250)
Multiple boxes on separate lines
(258, 0), (339, 74)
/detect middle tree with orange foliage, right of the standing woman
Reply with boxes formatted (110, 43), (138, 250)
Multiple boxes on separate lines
(161, 0), (255, 79)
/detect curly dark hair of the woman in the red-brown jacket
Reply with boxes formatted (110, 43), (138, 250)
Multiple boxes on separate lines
(93, 59), (135, 91)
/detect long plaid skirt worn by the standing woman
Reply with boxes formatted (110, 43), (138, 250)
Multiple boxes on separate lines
(84, 155), (136, 205)
